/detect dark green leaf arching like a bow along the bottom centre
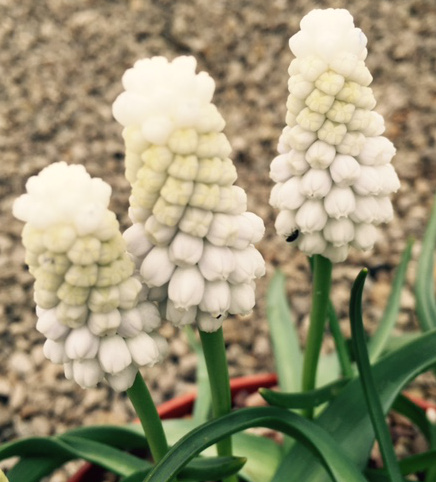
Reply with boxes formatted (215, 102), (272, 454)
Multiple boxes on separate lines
(146, 407), (366, 482)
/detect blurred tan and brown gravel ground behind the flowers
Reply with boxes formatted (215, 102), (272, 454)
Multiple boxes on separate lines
(0, 0), (436, 482)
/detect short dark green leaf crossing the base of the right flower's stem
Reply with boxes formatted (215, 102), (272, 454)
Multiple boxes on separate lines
(259, 378), (350, 409)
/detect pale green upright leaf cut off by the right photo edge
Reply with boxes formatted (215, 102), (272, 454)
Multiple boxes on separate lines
(415, 194), (436, 331)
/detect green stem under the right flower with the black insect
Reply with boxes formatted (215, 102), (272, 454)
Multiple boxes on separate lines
(302, 254), (332, 418)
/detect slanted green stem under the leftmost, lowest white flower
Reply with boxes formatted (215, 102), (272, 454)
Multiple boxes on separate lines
(127, 372), (168, 463)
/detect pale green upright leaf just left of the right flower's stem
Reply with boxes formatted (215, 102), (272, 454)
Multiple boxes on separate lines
(266, 270), (303, 392)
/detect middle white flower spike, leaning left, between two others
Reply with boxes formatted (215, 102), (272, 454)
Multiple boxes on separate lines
(113, 56), (265, 331)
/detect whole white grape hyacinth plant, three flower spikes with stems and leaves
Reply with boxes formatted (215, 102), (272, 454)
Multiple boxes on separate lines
(0, 9), (436, 482)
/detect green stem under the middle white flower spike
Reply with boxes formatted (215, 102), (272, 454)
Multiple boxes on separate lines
(199, 328), (237, 482)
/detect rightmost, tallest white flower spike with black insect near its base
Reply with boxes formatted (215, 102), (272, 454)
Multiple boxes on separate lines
(270, 9), (400, 262)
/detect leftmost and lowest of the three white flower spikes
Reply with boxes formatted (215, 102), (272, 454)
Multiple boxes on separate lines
(13, 162), (166, 391)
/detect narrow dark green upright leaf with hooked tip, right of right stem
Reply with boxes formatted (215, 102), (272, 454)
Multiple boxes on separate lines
(350, 269), (403, 482)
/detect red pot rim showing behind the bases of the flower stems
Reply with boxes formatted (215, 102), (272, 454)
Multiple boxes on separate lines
(68, 373), (277, 482)
